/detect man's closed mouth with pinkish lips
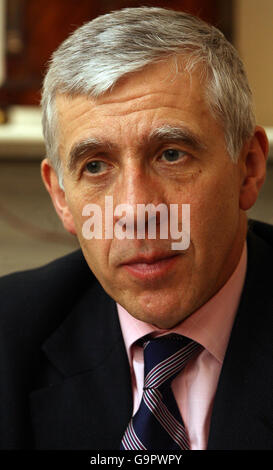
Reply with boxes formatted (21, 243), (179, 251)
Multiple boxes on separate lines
(121, 253), (179, 281)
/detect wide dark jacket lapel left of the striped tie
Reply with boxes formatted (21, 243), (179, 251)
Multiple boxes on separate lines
(30, 282), (132, 449)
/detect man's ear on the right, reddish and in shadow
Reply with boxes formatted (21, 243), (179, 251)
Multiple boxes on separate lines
(239, 126), (268, 211)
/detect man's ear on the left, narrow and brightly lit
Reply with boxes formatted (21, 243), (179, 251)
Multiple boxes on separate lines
(41, 158), (76, 235)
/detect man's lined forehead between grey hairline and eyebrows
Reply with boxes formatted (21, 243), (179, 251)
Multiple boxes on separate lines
(56, 59), (221, 154)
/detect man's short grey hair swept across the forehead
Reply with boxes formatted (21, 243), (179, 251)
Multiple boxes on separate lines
(42, 7), (255, 180)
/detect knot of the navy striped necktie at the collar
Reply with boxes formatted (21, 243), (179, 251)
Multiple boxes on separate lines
(143, 334), (201, 390)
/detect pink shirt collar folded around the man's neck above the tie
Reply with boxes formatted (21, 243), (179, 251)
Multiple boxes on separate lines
(117, 243), (247, 364)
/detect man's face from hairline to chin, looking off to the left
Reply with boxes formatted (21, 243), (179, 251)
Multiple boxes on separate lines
(52, 63), (246, 328)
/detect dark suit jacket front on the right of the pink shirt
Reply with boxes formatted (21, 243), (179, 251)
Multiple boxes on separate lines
(208, 232), (273, 450)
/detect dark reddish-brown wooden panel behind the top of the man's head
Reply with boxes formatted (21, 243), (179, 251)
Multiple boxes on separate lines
(0, 0), (224, 107)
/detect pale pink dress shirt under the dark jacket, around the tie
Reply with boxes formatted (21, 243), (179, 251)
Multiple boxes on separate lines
(117, 243), (247, 450)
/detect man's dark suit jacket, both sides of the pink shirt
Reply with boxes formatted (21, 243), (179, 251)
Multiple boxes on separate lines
(0, 218), (273, 450)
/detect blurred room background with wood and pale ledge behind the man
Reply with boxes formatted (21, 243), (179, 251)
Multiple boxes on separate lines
(0, 0), (273, 275)
